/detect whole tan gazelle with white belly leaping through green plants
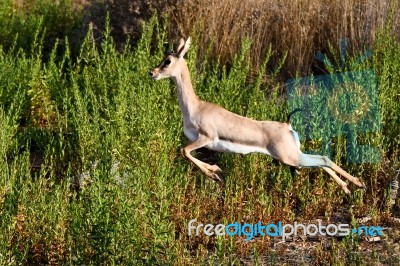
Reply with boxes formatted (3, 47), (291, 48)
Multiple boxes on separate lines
(150, 37), (365, 194)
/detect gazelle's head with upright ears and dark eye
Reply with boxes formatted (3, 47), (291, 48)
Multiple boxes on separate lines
(149, 37), (190, 80)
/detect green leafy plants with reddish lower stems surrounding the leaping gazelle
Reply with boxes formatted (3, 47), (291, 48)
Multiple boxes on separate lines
(0, 2), (400, 265)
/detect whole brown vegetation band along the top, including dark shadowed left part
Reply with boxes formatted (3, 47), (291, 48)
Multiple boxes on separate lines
(79, 0), (400, 77)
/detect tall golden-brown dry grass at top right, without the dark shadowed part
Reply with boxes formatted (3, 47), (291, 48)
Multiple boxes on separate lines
(170, 0), (399, 78)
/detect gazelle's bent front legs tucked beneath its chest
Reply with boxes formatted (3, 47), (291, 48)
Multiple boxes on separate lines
(181, 135), (222, 182)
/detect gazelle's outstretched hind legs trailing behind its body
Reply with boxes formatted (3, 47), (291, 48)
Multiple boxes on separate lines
(299, 153), (365, 193)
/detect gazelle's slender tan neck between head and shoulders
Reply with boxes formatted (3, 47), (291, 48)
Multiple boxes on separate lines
(173, 62), (199, 117)
